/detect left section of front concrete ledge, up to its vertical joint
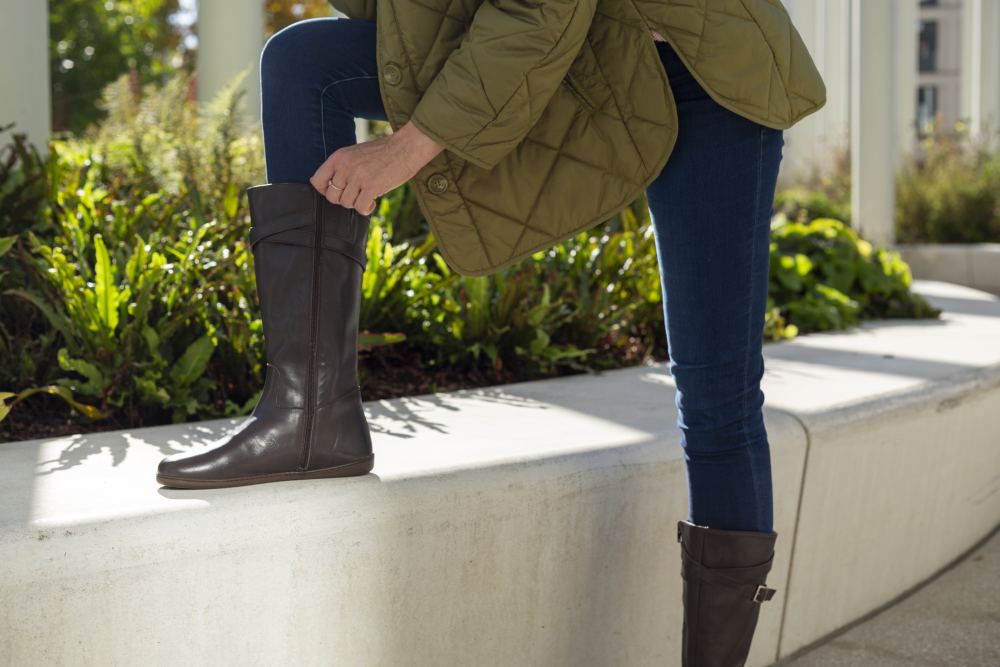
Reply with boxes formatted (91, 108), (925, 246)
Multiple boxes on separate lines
(0, 367), (805, 667)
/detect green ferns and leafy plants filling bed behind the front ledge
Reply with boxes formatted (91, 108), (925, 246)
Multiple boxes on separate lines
(0, 68), (933, 434)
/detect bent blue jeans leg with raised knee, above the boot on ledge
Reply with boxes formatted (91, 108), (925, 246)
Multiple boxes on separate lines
(260, 17), (386, 183)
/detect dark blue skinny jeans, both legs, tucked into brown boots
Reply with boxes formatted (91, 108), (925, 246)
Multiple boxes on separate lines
(260, 18), (784, 531)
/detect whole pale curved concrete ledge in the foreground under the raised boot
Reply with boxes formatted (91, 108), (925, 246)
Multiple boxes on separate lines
(0, 283), (1000, 666)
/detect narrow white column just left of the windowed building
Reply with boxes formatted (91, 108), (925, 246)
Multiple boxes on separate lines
(893, 0), (920, 166)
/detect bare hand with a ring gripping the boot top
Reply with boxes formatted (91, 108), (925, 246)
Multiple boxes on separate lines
(309, 122), (444, 215)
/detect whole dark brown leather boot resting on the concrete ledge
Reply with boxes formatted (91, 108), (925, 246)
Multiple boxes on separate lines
(156, 183), (375, 489)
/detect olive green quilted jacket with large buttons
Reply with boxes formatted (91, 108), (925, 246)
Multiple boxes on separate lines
(329, 0), (826, 276)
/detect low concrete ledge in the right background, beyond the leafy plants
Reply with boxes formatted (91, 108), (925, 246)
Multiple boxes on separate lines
(894, 243), (1000, 294)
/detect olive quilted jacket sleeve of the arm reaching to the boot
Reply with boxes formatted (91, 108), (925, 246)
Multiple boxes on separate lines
(410, 0), (597, 169)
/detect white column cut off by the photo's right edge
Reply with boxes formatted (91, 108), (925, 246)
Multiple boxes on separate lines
(962, 0), (1000, 135)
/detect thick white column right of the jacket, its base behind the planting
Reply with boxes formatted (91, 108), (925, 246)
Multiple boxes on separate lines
(851, 0), (896, 244)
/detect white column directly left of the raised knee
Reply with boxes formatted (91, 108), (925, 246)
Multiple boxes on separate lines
(198, 0), (264, 121)
